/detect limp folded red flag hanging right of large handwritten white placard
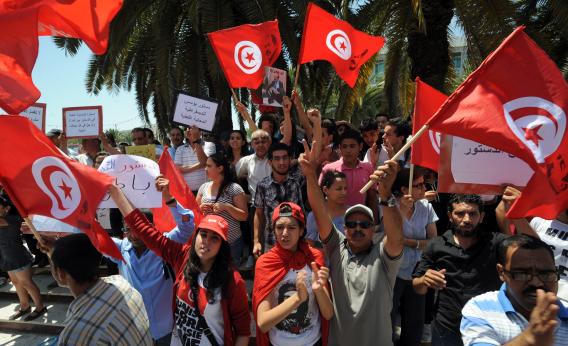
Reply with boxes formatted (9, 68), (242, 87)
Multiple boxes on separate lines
(152, 148), (203, 232)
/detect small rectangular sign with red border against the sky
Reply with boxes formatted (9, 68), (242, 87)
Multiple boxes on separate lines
(63, 106), (103, 138)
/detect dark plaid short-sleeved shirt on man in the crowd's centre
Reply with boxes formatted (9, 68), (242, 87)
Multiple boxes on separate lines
(254, 166), (307, 252)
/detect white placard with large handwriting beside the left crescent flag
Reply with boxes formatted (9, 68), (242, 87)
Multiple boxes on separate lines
(99, 155), (162, 208)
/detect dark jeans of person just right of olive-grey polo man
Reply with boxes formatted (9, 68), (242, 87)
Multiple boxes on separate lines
(391, 277), (425, 346)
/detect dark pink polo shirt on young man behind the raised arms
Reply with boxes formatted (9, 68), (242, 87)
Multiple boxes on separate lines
(319, 158), (374, 206)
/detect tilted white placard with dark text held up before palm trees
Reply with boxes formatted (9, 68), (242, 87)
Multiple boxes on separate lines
(173, 93), (219, 131)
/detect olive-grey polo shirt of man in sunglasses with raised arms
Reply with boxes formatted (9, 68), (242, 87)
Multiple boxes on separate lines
(324, 227), (402, 346)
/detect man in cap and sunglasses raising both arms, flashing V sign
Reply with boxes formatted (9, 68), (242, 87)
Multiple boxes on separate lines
(298, 138), (404, 345)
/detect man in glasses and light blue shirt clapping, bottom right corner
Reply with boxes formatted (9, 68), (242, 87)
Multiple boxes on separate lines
(460, 234), (568, 346)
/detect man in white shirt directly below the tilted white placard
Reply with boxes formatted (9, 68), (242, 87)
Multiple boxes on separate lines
(174, 126), (215, 196)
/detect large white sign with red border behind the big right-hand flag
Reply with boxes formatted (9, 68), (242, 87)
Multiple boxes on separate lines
(438, 135), (533, 194)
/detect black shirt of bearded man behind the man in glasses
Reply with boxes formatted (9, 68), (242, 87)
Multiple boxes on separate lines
(412, 230), (507, 333)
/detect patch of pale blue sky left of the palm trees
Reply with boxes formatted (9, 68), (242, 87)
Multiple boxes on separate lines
(32, 37), (143, 131)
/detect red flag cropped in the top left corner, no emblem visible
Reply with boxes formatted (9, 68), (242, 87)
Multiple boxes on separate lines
(0, 0), (122, 114)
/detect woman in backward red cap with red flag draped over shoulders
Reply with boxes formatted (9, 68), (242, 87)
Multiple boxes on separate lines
(252, 202), (333, 346)
